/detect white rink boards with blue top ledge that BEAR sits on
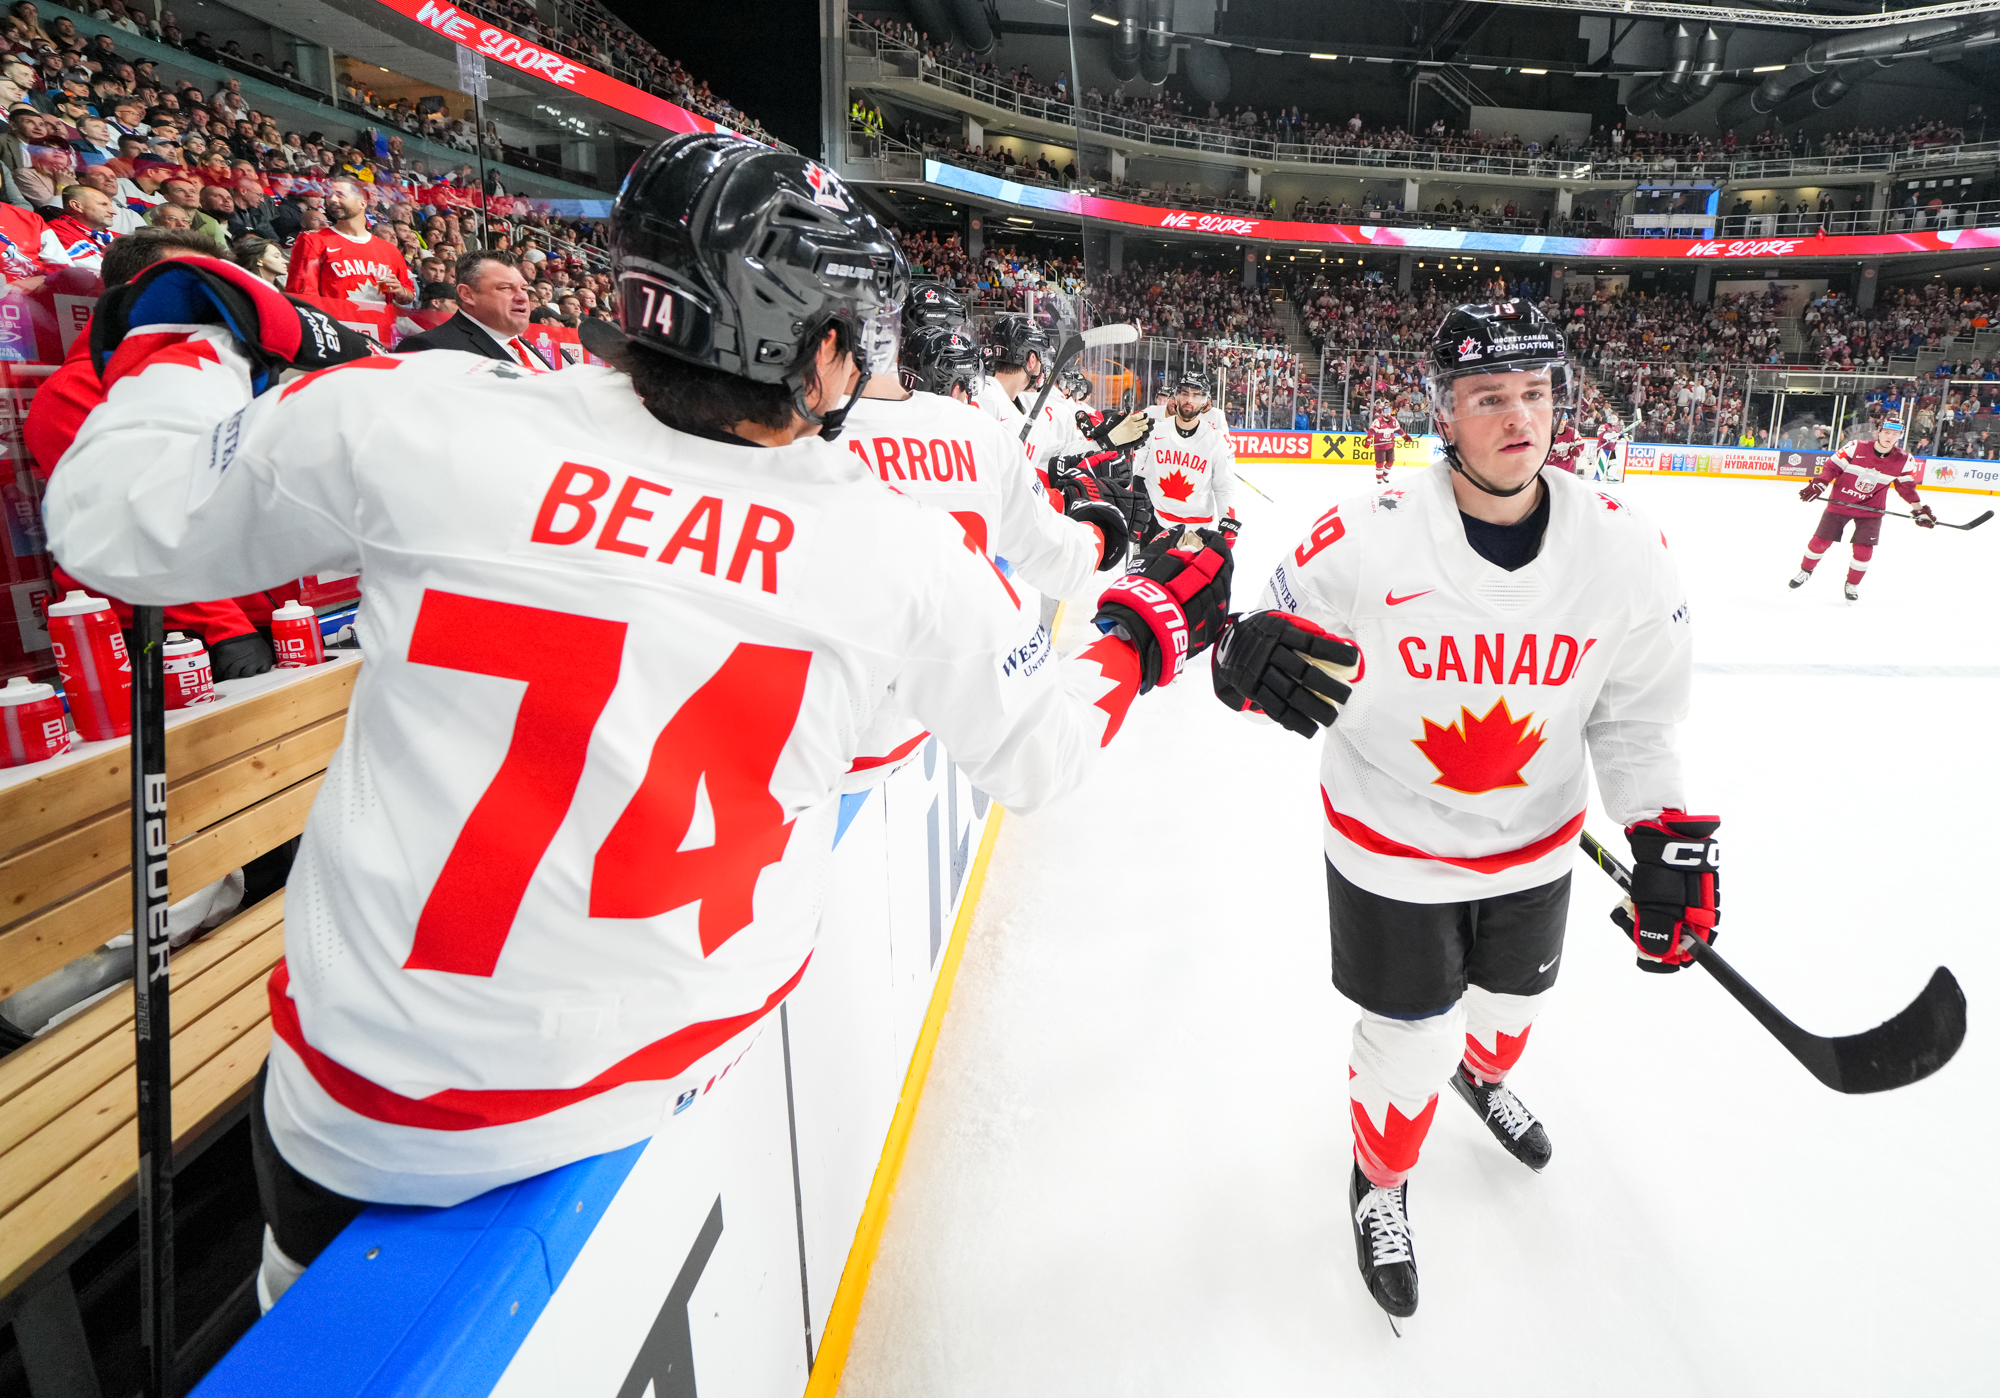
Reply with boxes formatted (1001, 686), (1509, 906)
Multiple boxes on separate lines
(196, 738), (998, 1398)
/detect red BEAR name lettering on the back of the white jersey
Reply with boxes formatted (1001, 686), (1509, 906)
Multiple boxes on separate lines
(512, 462), (810, 594)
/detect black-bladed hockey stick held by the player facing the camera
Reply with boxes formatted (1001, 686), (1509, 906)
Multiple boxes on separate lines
(1582, 830), (1966, 1092)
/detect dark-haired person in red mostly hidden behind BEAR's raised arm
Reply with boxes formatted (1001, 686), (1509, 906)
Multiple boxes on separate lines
(20, 231), (276, 680)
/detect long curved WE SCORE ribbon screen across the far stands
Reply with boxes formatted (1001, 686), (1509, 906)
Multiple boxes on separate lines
(924, 160), (2000, 262)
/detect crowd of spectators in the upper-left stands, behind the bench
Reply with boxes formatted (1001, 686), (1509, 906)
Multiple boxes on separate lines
(0, 0), (612, 340)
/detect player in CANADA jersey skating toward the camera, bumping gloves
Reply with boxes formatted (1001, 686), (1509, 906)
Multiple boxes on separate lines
(1212, 300), (1720, 1318)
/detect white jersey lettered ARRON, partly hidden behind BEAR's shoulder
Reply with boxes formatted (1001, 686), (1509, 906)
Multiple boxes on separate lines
(840, 392), (1104, 790)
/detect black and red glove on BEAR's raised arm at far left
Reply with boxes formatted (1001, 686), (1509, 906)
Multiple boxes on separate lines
(90, 258), (376, 394)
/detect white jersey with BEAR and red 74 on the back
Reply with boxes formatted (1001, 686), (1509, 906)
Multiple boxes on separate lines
(46, 330), (1138, 1204)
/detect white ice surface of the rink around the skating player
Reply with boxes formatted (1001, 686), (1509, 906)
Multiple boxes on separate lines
(842, 466), (2000, 1398)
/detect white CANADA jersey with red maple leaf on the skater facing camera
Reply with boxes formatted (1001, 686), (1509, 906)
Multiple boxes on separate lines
(1262, 464), (1694, 902)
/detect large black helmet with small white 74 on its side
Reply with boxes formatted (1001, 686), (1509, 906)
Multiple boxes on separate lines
(610, 132), (908, 436)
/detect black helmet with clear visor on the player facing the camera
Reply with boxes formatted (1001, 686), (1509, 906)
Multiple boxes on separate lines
(1424, 298), (1580, 496)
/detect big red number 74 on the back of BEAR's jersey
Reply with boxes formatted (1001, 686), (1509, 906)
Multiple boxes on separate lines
(404, 590), (812, 976)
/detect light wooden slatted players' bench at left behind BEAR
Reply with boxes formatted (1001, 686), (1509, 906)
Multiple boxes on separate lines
(0, 654), (360, 1398)
